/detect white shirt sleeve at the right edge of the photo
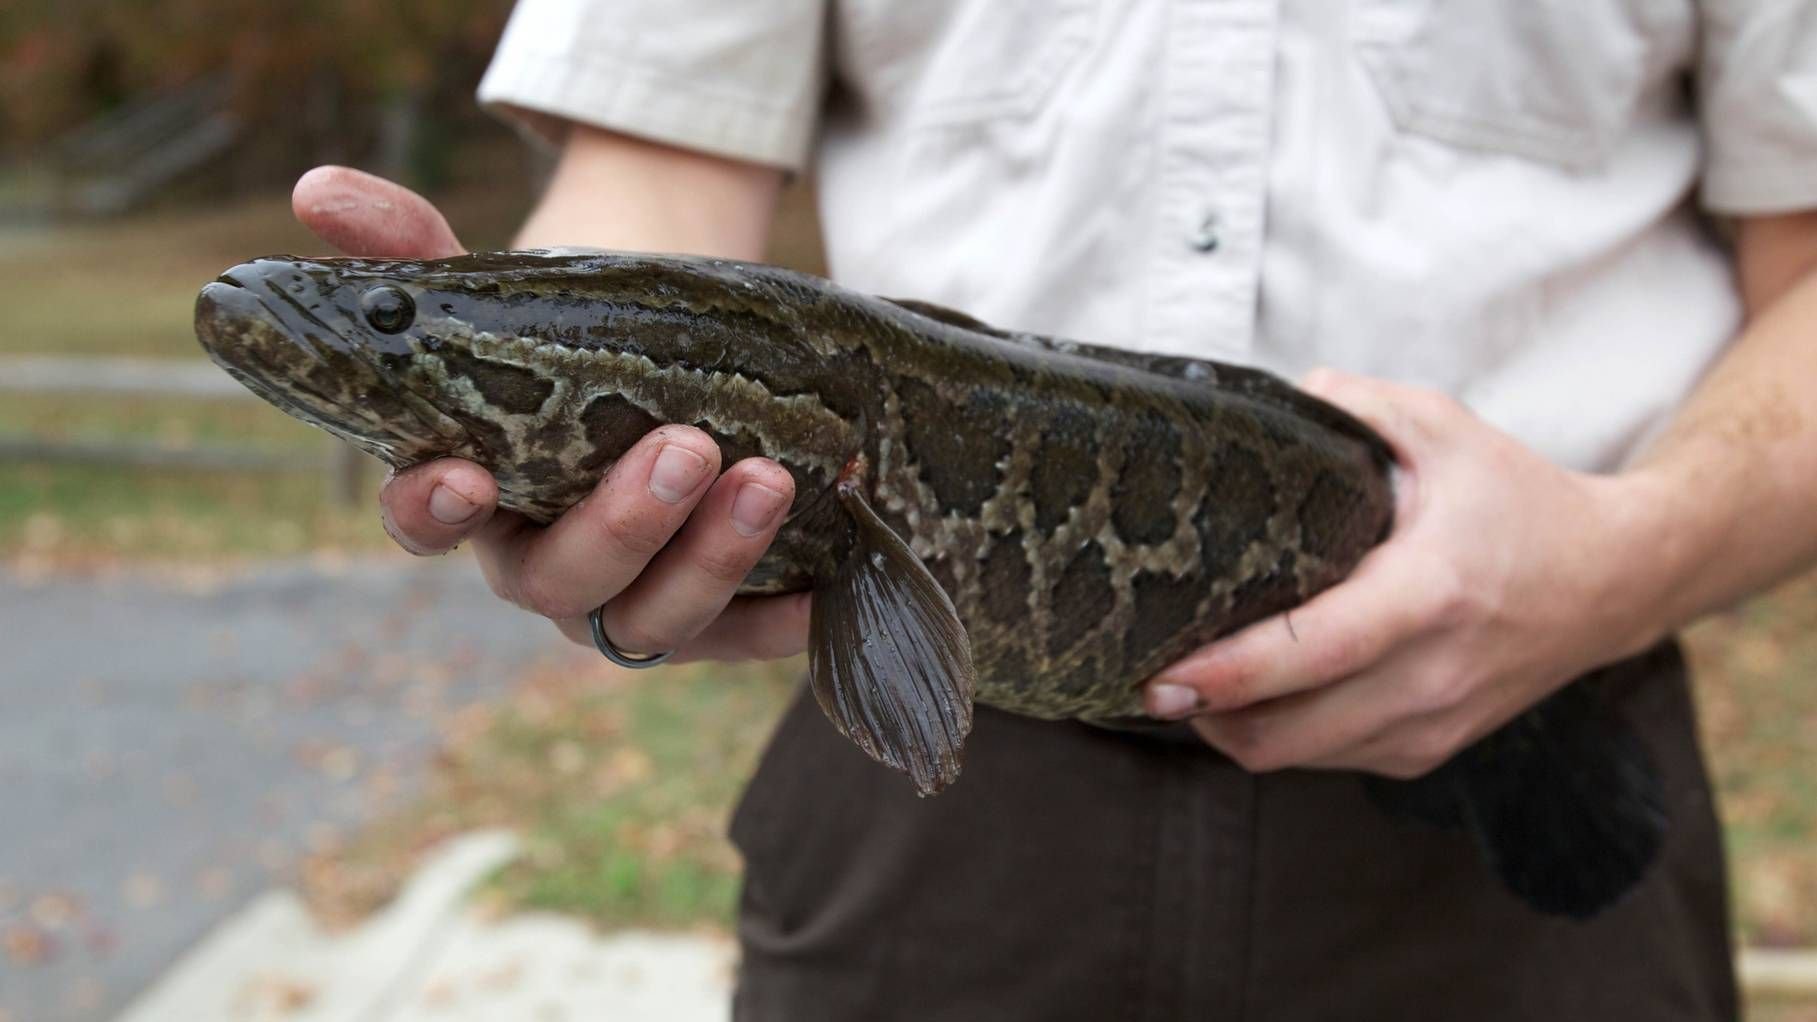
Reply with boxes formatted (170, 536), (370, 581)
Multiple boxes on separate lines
(1697, 0), (1817, 215)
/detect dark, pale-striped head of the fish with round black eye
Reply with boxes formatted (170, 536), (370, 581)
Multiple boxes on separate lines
(196, 251), (745, 520)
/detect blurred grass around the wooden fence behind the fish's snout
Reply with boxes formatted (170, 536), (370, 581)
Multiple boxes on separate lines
(0, 149), (529, 564)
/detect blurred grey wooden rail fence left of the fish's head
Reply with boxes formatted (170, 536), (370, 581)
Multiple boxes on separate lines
(0, 355), (371, 504)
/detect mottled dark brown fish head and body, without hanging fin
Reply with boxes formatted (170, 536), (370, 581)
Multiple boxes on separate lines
(196, 253), (1392, 720)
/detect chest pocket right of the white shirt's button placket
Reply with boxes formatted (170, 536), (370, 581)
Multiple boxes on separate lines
(1352, 0), (1692, 169)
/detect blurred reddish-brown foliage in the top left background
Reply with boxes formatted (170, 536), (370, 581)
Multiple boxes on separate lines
(0, 0), (511, 190)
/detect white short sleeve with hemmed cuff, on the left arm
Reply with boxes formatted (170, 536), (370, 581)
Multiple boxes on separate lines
(480, 0), (827, 169)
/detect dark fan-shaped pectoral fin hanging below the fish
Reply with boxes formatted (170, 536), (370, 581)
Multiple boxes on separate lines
(809, 487), (978, 795)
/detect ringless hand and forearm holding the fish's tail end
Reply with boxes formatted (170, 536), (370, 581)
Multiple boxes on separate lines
(1147, 211), (1817, 777)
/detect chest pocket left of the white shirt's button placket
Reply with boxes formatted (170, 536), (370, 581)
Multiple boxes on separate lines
(839, 0), (1103, 127)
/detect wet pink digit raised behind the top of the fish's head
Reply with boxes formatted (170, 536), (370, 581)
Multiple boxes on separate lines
(291, 167), (463, 258)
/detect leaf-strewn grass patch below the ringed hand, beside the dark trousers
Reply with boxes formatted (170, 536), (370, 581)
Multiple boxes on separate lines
(303, 662), (801, 929)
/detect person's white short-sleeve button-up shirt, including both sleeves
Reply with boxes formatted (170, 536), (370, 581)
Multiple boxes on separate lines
(480, 0), (1817, 469)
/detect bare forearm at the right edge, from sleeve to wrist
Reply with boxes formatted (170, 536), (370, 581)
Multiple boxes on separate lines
(1608, 216), (1817, 633)
